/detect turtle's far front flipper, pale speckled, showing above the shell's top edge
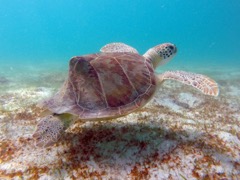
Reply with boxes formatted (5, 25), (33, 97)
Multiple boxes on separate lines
(100, 43), (138, 54)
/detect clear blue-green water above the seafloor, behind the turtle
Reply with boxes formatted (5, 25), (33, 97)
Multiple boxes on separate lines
(0, 0), (240, 67)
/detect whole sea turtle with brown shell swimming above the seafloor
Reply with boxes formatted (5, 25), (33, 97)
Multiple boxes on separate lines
(33, 43), (219, 146)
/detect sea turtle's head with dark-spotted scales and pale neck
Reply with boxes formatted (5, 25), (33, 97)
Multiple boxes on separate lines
(143, 43), (177, 69)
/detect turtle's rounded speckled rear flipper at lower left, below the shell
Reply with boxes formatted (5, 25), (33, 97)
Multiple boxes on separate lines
(33, 115), (64, 147)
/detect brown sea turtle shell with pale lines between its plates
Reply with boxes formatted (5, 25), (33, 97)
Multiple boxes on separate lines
(44, 52), (156, 119)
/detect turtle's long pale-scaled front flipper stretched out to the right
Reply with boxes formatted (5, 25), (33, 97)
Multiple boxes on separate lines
(158, 71), (219, 96)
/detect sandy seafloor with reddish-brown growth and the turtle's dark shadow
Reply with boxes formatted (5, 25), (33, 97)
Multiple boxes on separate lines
(0, 63), (240, 180)
